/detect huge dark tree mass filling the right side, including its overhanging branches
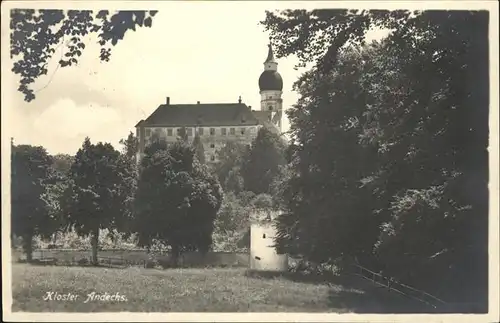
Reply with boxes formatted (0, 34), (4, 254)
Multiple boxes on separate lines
(264, 10), (489, 308)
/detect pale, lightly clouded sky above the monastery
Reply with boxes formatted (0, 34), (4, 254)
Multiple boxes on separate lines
(2, 2), (390, 154)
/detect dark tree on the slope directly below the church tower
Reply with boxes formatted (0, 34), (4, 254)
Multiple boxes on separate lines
(241, 127), (286, 194)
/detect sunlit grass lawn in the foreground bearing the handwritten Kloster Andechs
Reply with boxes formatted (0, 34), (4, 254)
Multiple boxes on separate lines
(12, 264), (430, 313)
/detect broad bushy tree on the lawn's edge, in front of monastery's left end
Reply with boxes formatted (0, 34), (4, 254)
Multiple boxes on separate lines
(135, 141), (222, 264)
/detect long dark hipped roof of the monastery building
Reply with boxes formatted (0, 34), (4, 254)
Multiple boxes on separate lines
(138, 103), (259, 127)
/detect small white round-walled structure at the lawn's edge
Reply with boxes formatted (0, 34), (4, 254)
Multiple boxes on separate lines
(250, 211), (288, 272)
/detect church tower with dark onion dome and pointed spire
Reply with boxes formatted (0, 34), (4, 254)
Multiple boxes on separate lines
(259, 44), (283, 133)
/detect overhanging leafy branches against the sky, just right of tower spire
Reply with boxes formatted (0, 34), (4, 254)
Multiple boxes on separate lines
(260, 9), (412, 73)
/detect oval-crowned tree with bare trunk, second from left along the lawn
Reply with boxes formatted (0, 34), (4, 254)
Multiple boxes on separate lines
(63, 138), (129, 265)
